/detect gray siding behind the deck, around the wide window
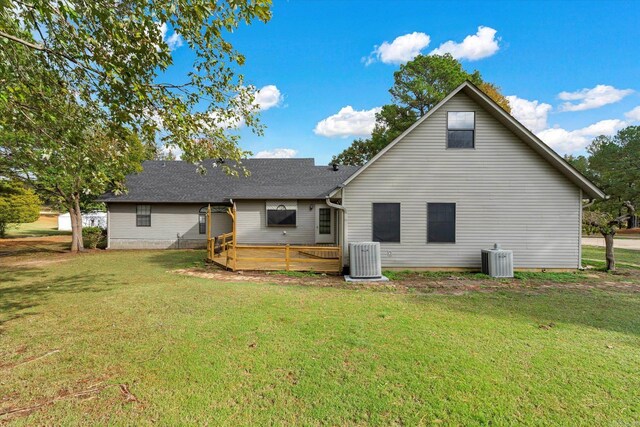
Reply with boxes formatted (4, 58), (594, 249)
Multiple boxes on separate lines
(236, 200), (324, 245)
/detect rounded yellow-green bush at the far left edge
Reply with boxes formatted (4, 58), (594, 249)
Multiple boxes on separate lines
(0, 180), (41, 237)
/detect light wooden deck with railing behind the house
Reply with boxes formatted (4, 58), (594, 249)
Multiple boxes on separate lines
(207, 206), (342, 273)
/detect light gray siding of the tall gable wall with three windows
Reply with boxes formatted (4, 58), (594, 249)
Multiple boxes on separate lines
(343, 93), (581, 268)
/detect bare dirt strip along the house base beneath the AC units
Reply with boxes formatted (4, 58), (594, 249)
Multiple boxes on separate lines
(171, 267), (640, 295)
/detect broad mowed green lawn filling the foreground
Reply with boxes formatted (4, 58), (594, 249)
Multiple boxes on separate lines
(0, 251), (640, 425)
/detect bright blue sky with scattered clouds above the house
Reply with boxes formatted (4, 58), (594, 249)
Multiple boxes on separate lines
(167, 0), (640, 163)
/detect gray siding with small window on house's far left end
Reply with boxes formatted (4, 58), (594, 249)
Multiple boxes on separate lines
(109, 203), (231, 249)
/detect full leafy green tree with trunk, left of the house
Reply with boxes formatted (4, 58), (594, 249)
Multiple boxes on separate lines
(0, 36), (149, 250)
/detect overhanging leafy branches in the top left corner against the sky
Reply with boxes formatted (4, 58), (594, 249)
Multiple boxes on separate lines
(0, 0), (271, 165)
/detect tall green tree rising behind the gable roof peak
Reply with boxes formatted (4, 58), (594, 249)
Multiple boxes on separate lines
(331, 54), (511, 165)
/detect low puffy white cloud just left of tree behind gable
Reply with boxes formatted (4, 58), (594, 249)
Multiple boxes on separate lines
(313, 105), (381, 137)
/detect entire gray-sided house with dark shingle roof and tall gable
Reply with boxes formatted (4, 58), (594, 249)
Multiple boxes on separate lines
(104, 82), (605, 269)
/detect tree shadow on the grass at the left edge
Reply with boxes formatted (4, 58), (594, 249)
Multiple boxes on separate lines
(0, 267), (122, 327)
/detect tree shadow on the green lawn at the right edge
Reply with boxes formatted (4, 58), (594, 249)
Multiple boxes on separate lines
(415, 289), (640, 336)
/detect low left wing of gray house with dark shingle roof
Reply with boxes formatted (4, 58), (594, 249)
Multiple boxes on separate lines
(102, 159), (357, 249)
